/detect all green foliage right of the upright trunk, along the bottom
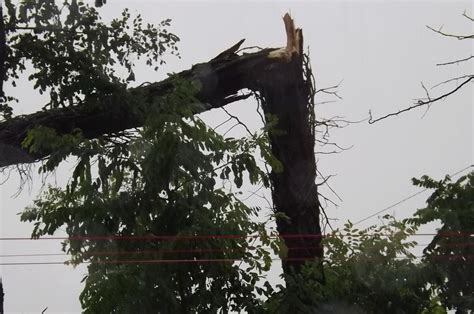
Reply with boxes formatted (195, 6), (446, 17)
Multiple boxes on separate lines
(265, 172), (474, 313)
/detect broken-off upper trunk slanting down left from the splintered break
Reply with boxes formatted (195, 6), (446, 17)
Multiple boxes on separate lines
(0, 40), (288, 167)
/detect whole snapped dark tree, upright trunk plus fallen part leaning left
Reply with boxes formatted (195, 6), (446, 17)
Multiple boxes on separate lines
(0, 14), (323, 273)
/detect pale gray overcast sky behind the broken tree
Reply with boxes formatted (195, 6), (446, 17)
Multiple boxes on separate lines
(0, 0), (474, 313)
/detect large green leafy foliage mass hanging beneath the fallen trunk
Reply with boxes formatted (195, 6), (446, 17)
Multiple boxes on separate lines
(21, 75), (282, 313)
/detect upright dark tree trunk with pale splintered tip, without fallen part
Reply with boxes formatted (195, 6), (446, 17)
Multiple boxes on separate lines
(259, 15), (323, 273)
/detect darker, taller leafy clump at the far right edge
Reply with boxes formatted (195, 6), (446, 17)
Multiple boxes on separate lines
(406, 172), (474, 313)
